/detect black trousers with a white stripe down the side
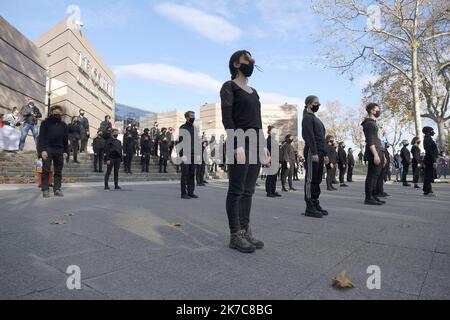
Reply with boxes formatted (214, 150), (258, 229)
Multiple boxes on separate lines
(304, 149), (324, 205)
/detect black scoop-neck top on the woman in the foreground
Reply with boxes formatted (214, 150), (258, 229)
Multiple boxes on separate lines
(220, 81), (262, 130)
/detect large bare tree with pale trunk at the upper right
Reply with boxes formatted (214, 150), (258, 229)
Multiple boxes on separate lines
(311, 0), (450, 148)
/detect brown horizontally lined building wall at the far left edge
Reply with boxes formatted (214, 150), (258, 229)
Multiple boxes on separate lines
(0, 16), (47, 149)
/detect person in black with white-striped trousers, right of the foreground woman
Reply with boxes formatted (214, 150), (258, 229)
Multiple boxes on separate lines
(302, 96), (330, 218)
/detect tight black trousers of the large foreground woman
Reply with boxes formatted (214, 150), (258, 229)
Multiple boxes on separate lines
(226, 164), (261, 233)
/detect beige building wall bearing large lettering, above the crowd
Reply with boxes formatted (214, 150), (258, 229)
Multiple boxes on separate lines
(35, 18), (115, 138)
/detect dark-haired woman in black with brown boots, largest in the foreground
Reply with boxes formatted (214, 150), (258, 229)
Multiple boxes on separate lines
(220, 50), (273, 253)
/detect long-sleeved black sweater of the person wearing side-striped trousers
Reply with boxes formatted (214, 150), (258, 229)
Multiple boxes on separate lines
(302, 110), (328, 156)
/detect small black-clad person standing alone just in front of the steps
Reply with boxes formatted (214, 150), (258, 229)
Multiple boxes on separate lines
(105, 129), (122, 190)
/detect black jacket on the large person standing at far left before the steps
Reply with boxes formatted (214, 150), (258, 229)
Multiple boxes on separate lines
(37, 116), (69, 153)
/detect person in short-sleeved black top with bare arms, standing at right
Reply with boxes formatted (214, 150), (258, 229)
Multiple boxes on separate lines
(361, 103), (385, 206)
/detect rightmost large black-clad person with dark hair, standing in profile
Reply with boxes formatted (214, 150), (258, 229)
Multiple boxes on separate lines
(422, 127), (439, 197)
